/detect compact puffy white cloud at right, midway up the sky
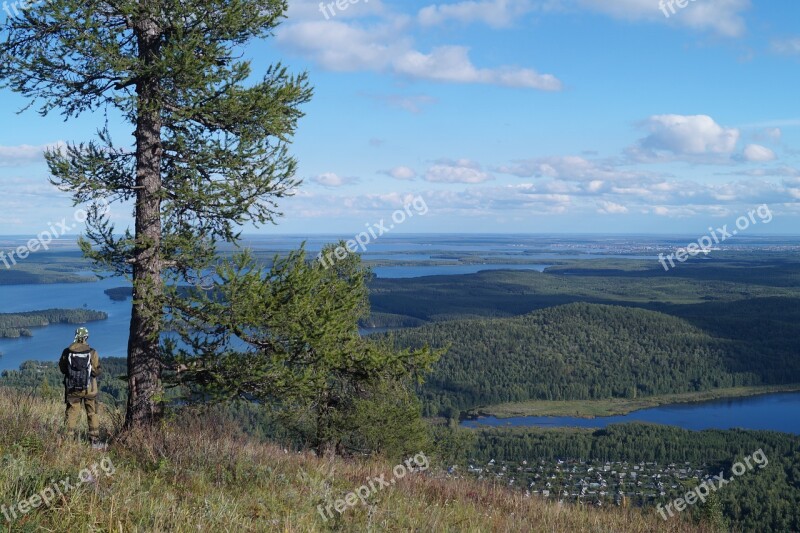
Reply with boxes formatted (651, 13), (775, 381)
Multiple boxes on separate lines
(628, 115), (741, 162)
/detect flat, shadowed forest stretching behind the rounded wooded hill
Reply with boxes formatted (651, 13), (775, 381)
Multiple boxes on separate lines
(370, 253), (800, 325)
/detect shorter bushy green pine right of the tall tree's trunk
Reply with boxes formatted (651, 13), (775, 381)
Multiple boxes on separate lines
(166, 243), (442, 456)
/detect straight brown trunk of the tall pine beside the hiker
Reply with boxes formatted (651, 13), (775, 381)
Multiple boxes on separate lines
(125, 10), (163, 428)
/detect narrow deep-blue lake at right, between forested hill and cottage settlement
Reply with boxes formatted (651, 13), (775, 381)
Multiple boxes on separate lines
(462, 392), (800, 435)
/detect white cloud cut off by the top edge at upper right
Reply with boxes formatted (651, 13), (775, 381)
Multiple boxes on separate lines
(577, 0), (750, 37)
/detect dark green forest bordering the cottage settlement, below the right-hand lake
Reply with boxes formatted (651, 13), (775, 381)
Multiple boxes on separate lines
(472, 424), (800, 532)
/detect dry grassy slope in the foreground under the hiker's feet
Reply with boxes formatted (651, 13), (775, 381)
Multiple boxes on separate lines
(0, 389), (703, 532)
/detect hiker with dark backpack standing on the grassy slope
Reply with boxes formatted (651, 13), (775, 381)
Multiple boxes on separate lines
(58, 328), (102, 448)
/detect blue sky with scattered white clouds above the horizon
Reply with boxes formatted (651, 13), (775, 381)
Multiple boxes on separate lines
(0, 0), (800, 235)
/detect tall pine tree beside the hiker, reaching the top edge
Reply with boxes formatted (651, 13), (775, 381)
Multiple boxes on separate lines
(0, 0), (311, 427)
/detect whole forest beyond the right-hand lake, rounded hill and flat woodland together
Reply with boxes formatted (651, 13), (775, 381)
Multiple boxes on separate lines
(370, 252), (800, 416)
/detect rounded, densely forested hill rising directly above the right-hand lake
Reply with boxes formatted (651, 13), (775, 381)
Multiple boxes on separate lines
(393, 303), (800, 415)
